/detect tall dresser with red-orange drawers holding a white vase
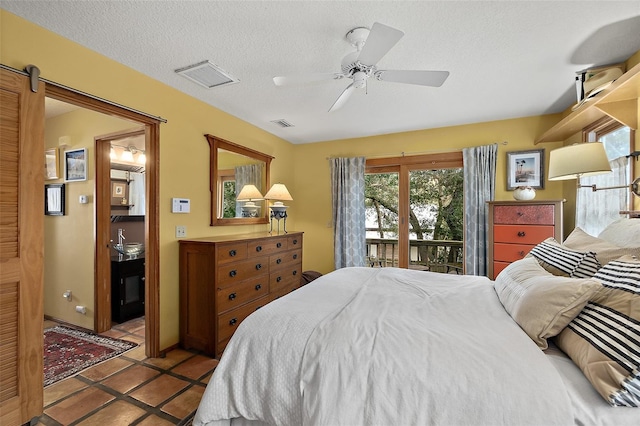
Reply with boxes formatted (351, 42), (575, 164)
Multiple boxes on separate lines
(487, 200), (564, 279)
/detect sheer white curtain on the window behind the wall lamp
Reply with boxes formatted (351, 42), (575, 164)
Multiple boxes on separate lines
(576, 157), (629, 236)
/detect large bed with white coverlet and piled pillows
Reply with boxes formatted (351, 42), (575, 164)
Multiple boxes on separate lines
(194, 221), (640, 426)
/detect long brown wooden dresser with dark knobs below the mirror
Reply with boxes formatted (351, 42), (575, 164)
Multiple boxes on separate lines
(179, 232), (302, 358)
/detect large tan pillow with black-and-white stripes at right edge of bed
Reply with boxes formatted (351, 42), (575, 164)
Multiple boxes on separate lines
(556, 256), (640, 407)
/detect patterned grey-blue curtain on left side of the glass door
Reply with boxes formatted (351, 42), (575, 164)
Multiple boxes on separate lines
(330, 157), (367, 269)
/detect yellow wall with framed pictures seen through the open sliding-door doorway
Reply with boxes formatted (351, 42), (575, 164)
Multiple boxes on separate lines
(44, 109), (133, 329)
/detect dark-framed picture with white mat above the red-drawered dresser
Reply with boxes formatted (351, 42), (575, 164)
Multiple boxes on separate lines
(507, 149), (544, 190)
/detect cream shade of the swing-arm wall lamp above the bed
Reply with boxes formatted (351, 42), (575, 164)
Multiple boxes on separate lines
(549, 142), (611, 180)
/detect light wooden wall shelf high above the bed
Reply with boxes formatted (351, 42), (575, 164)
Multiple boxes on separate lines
(535, 64), (640, 144)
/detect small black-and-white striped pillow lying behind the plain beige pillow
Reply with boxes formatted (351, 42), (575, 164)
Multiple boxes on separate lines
(529, 238), (601, 278)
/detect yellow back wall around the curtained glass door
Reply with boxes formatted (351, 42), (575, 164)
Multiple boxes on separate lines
(292, 115), (562, 273)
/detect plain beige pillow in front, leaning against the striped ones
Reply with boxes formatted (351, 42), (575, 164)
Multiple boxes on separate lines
(494, 257), (602, 349)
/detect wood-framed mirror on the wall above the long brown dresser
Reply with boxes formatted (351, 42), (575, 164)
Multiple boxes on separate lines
(205, 134), (273, 226)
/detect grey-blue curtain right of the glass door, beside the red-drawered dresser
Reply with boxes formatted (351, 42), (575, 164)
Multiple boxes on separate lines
(462, 144), (498, 275)
